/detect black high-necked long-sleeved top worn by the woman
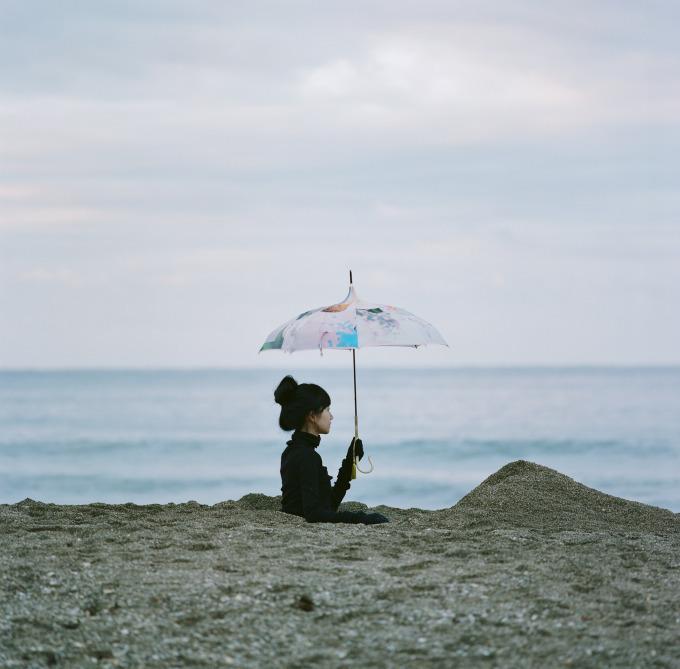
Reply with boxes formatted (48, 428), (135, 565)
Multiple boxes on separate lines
(281, 430), (357, 523)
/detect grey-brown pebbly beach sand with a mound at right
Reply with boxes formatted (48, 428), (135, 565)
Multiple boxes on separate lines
(0, 461), (680, 668)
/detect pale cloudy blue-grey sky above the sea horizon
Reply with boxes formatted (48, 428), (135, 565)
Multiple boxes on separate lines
(0, 0), (680, 369)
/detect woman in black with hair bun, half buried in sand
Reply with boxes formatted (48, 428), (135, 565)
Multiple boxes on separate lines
(274, 376), (389, 525)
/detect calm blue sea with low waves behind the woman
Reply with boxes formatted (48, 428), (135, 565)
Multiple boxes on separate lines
(0, 367), (680, 513)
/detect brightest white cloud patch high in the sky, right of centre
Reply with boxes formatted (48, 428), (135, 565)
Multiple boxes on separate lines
(301, 38), (583, 142)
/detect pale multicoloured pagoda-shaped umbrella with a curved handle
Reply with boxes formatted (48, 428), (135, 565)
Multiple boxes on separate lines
(260, 271), (448, 478)
